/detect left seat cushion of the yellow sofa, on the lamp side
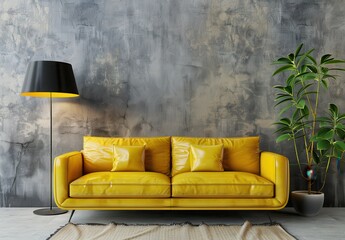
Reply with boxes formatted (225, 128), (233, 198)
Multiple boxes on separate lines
(70, 172), (170, 198)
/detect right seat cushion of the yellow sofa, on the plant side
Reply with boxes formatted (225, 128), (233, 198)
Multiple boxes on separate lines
(172, 172), (274, 198)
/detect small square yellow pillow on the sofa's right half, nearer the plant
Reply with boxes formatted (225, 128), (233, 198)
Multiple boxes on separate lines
(189, 144), (224, 172)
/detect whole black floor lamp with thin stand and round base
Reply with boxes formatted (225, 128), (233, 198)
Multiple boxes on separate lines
(21, 61), (79, 215)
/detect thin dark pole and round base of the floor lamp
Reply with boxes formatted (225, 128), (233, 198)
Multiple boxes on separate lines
(34, 93), (68, 216)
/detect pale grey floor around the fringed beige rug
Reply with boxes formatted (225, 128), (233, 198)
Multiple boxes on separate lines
(0, 208), (345, 240)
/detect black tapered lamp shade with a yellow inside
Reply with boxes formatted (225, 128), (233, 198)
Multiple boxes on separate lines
(21, 61), (79, 98)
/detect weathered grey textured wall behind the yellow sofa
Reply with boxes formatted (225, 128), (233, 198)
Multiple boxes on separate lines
(0, 0), (345, 206)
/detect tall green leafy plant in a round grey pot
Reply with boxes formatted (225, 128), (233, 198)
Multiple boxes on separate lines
(273, 44), (345, 216)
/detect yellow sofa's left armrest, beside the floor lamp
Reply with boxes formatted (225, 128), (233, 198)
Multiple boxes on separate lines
(54, 152), (83, 207)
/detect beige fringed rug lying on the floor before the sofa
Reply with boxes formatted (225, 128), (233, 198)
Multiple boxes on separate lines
(49, 222), (295, 240)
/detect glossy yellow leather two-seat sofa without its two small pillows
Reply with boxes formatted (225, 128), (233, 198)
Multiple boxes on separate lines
(54, 136), (289, 210)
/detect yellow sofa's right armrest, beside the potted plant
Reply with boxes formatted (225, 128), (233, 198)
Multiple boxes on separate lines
(260, 152), (290, 208)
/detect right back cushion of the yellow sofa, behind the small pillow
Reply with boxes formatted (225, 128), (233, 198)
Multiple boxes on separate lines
(171, 136), (260, 176)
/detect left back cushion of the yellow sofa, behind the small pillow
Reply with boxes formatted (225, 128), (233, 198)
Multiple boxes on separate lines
(82, 136), (171, 175)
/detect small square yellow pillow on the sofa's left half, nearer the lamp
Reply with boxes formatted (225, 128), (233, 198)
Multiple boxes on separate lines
(111, 145), (145, 172)
